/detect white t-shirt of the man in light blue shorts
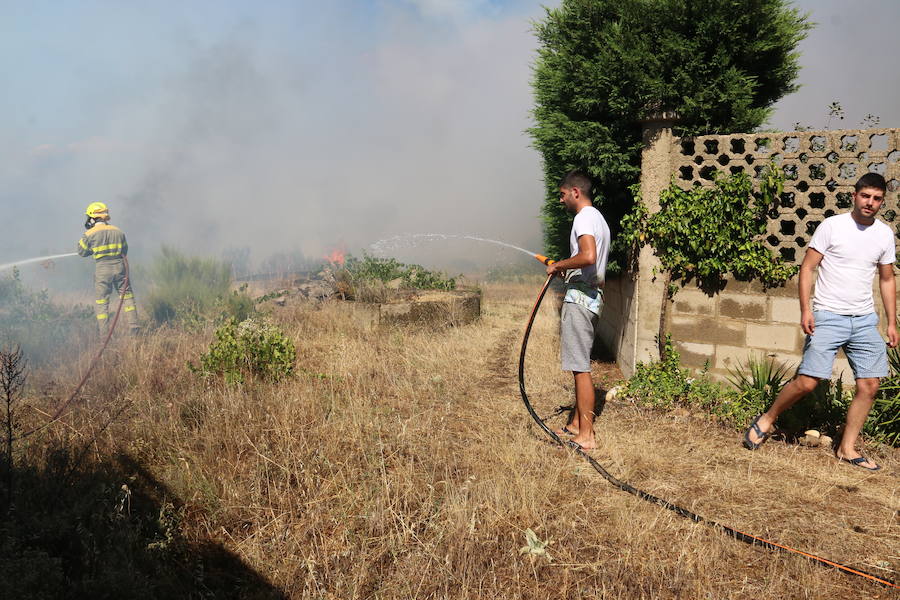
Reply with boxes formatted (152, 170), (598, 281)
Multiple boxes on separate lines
(809, 213), (897, 315)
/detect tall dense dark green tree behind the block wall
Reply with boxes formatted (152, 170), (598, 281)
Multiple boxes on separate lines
(529, 0), (811, 269)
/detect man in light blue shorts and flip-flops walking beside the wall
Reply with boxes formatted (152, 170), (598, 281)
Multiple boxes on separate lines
(744, 173), (898, 471)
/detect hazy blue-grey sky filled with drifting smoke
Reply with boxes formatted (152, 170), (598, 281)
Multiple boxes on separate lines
(0, 0), (900, 263)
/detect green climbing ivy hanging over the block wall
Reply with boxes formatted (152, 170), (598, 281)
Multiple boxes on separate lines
(619, 169), (797, 296)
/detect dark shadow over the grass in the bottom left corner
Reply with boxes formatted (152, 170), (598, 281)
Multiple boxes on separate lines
(0, 448), (285, 599)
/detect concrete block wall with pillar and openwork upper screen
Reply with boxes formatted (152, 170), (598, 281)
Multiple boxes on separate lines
(599, 113), (900, 383)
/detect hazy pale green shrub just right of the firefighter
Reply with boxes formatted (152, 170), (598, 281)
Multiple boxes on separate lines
(144, 246), (254, 326)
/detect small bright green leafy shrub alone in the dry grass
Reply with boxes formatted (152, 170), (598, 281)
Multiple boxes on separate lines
(188, 318), (297, 383)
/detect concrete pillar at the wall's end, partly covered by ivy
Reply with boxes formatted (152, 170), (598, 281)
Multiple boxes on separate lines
(618, 111), (677, 377)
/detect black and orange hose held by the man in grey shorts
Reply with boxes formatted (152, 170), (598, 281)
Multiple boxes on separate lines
(519, 254), (900, 588)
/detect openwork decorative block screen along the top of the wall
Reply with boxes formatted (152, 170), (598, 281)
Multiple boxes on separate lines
(672, 129), (900, 262)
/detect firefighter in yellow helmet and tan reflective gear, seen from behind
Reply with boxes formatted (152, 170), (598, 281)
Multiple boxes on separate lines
(77, 202), (138, 335)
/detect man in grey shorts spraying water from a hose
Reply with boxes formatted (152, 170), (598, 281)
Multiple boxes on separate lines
(547, 171), (609, 450)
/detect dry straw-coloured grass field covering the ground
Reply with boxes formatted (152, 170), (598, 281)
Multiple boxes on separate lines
(15, 281), (900, 599)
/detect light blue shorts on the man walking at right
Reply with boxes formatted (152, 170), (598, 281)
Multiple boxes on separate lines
(797, 310), (888, 379)
